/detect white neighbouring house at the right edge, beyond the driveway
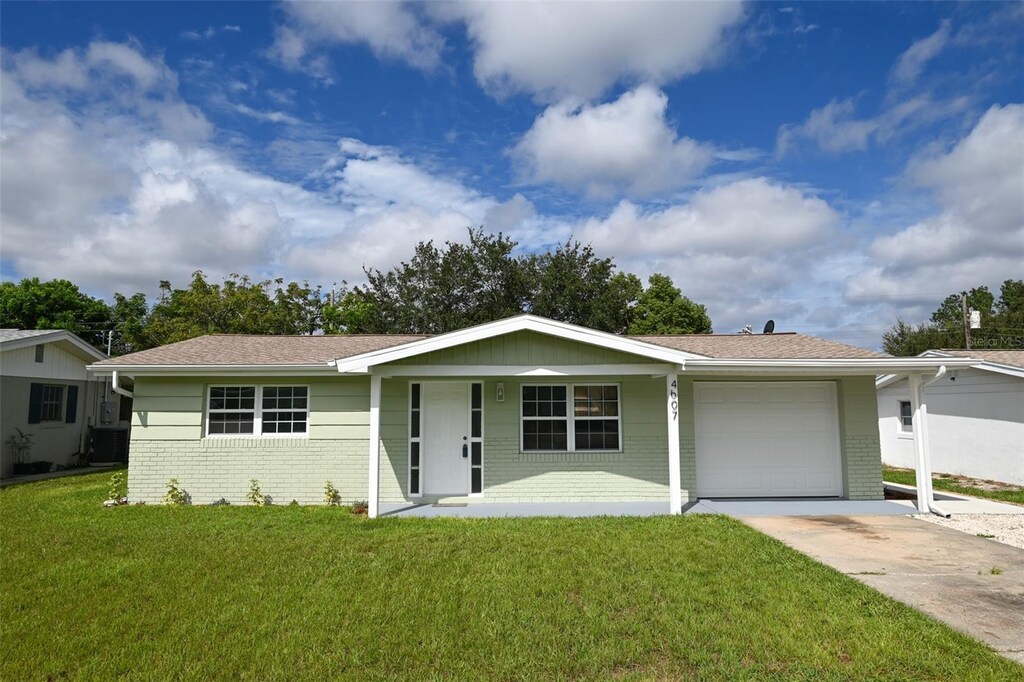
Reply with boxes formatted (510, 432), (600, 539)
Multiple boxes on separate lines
(877, 350), (1024, 485)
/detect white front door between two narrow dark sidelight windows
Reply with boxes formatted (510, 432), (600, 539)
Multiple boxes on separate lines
(422, 382), (469, 495)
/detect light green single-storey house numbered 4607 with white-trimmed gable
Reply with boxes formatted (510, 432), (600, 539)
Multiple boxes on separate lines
(91, 315), (969, 515)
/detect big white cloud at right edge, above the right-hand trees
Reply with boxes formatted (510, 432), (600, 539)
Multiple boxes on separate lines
(847, 104), (1024, 298)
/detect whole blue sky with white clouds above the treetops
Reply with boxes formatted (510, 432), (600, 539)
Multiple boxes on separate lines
(0, 2), (1024, 346)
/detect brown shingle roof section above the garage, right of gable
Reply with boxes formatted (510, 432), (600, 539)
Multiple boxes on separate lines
(630, 333), (888, 359)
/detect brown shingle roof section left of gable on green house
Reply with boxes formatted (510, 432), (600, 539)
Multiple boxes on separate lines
(97, 334), (427, 367)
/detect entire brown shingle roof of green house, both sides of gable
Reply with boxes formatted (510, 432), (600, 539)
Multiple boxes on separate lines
(97, 334), (886, 367)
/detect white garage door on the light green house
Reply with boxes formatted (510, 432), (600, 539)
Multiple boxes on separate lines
(693, 381), (843, 498)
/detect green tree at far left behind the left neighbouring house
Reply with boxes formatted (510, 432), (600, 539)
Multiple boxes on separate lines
(0, 278), (113, 351)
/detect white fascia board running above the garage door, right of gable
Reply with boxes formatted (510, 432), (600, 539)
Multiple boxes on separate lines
(683, 357), (978, 375)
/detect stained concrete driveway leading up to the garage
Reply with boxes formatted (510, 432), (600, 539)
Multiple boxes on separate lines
(741, 516), (1024, 664)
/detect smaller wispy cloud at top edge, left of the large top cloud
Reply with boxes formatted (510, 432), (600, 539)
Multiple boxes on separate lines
(270, 2), (444, 78)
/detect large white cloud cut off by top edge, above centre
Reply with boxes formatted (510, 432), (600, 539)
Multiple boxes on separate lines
(431, 2), (743, 101)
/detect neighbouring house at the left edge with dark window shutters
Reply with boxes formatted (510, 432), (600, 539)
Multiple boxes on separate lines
(0, 329), (118, 478)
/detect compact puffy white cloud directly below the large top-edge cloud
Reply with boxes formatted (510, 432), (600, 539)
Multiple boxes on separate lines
(511, 85), (715, 197)
